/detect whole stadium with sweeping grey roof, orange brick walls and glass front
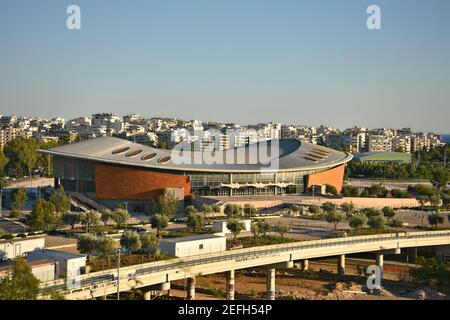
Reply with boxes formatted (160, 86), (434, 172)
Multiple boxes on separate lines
(39, 137), (352, 210)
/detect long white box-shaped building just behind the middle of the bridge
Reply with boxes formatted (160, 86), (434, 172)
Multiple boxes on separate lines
(160, 234), (227, 258)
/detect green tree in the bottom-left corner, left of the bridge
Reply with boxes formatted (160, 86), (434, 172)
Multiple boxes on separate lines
(0, 258), (39, 301)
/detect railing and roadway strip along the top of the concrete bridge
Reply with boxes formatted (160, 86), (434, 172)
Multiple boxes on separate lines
(42, 230), (450, 296)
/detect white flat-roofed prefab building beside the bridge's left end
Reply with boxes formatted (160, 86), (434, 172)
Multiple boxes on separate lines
(27, 249), (86, 278)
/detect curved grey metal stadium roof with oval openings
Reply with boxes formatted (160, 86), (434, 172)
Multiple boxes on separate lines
(39, 137), (353, 173)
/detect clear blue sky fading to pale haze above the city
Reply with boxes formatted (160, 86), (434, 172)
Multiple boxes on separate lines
(0, 0), (450, 133)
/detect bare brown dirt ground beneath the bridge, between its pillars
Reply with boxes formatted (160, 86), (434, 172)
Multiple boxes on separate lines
(170, 270), (449, 300)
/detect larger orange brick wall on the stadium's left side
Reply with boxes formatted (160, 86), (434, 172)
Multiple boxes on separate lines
(95, 163), (191, 200)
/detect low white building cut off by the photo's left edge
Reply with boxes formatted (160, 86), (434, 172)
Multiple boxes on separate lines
(0, 236), (45, 261)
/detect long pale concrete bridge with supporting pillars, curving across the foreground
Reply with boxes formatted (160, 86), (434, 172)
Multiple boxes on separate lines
(42, 231), (450, 300)
